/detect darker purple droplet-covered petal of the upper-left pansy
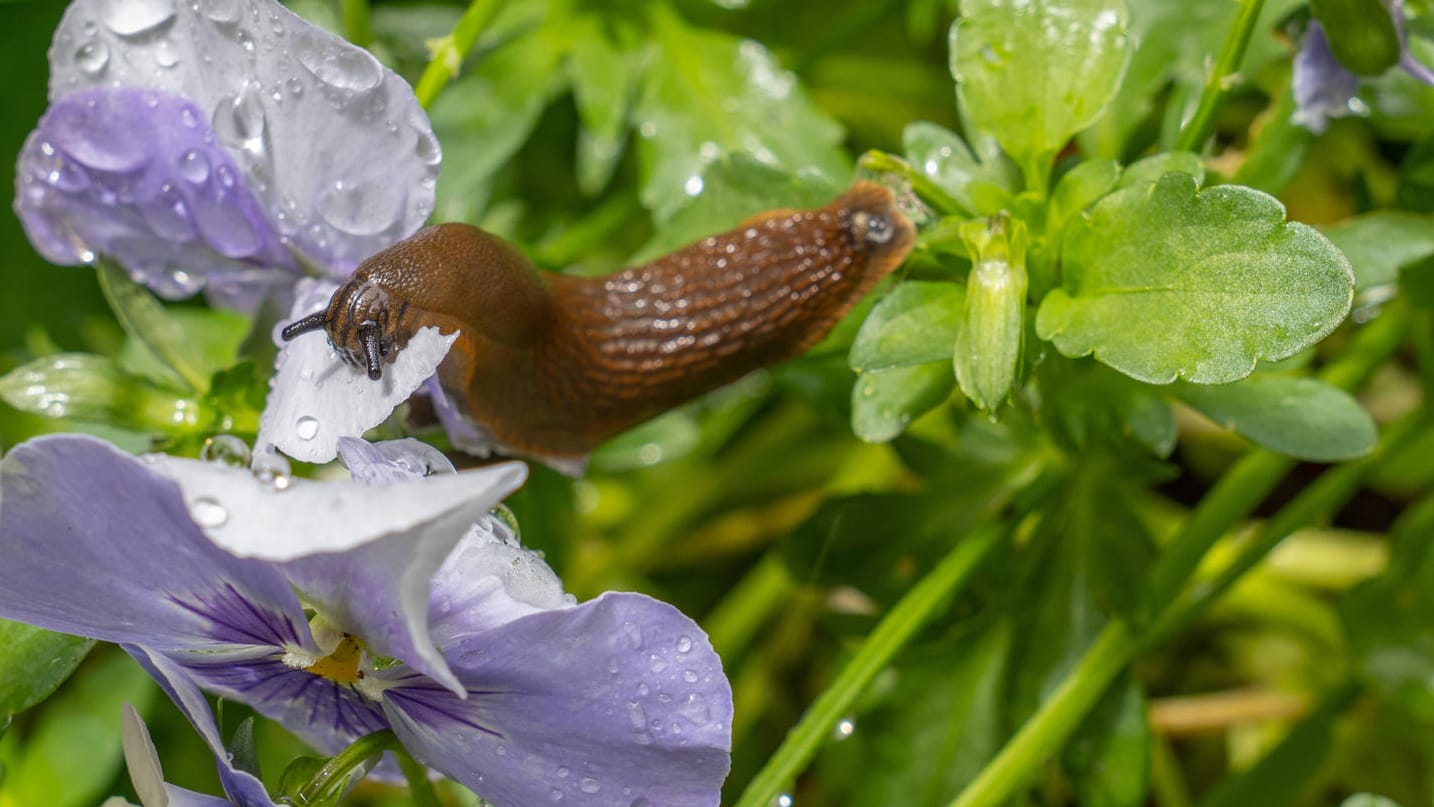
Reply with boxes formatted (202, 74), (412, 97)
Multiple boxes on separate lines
(16, 89), (297, 309)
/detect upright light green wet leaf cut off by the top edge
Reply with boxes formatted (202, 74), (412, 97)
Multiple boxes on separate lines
(951, 0), (1130, 176)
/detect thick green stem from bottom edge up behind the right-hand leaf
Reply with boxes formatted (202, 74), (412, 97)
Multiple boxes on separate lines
(952, 305), (1405, 807)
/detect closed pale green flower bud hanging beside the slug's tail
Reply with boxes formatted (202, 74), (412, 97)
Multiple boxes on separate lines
(954, 212), (1028, 411)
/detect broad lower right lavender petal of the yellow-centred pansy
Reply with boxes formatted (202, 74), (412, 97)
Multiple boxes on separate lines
(383, 593), (731, 807)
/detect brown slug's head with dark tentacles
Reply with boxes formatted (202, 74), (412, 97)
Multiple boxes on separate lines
(280, 277), (409, 381)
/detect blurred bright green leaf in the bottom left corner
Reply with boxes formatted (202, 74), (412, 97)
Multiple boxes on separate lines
(0, 652), (158, 807)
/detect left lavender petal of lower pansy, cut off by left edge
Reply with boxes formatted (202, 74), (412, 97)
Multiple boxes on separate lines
(0, 434), (314, 648)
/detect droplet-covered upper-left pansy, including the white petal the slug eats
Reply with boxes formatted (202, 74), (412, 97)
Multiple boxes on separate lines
(14, 0), (453, 462)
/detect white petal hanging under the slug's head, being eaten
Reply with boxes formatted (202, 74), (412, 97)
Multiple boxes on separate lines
(257, 281), (457, 463)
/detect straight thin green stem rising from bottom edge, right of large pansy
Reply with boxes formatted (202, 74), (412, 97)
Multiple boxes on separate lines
(736, 525), (1005, 807)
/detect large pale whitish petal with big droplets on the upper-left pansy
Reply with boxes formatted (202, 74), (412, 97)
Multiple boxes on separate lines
(50, 0), (440, 275)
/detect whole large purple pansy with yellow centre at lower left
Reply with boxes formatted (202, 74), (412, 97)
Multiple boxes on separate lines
(0, 436), (731, 807)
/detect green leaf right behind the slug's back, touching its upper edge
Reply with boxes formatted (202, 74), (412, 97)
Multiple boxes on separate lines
(634, 153), (842, 261)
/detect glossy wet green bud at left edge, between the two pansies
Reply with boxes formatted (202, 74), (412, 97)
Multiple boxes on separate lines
(0, 353), (205, 433)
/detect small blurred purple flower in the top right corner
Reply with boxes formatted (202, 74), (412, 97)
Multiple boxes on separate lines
(1292, 0), (1434, 135)
